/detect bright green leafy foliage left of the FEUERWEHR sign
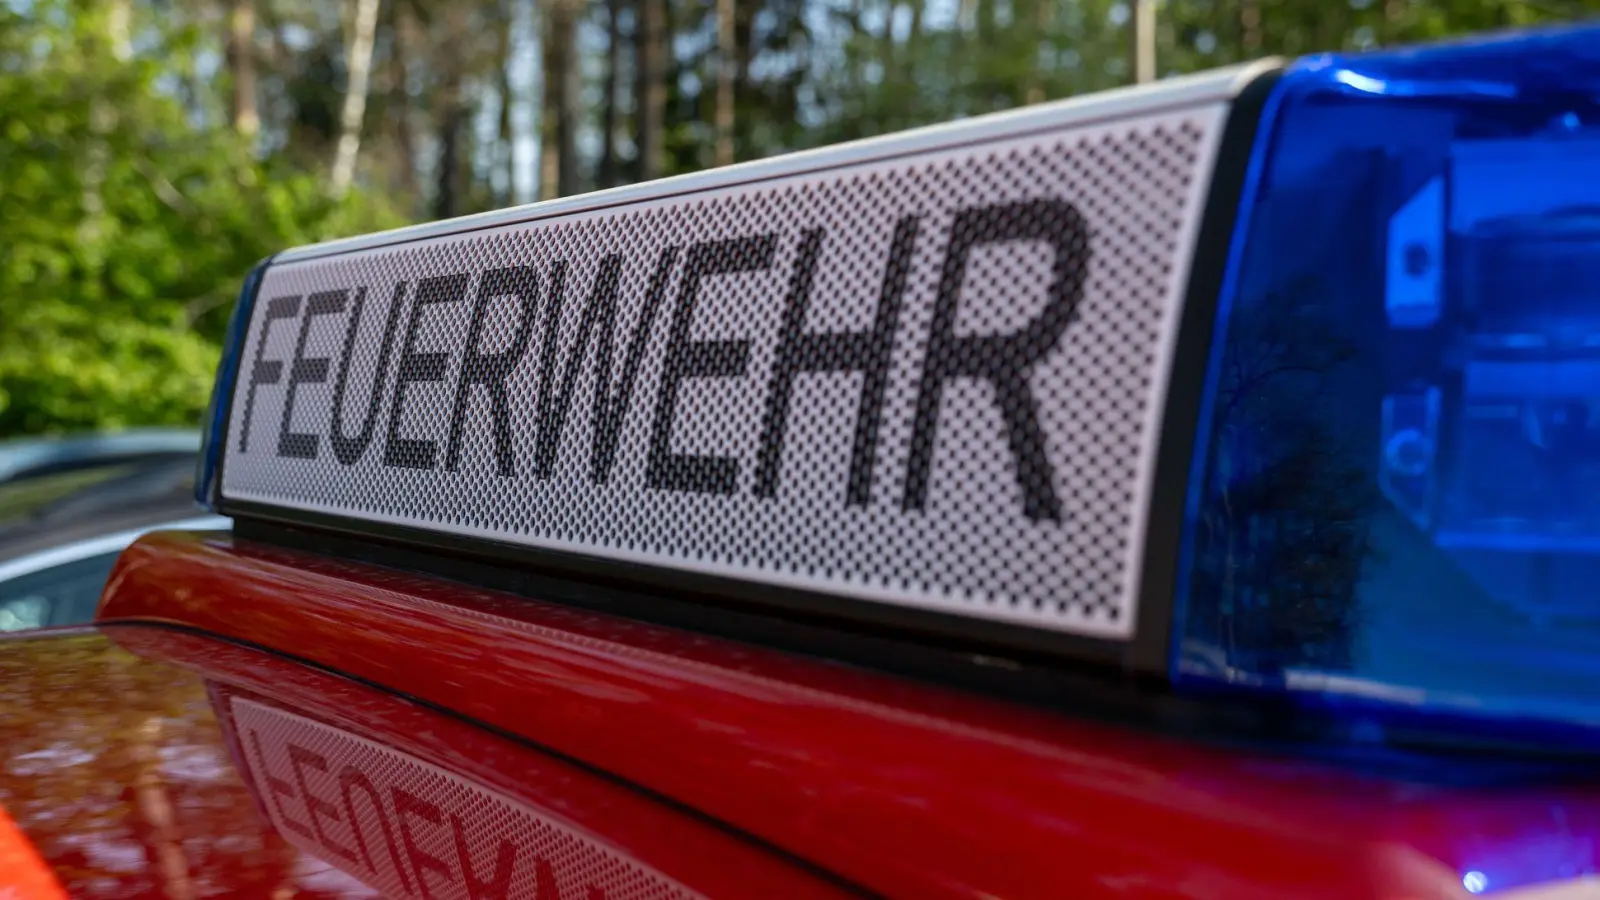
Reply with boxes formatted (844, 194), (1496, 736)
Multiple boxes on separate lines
(0, 2), (400, 436)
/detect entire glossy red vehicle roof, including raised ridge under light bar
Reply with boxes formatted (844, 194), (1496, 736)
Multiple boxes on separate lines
(0, 522), (1600, 900)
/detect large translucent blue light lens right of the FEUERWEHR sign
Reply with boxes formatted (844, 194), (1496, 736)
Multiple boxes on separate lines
(1171, 26), (1600, 725)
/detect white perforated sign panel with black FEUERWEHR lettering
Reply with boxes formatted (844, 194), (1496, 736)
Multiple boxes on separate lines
(222, 99), (1226, 639)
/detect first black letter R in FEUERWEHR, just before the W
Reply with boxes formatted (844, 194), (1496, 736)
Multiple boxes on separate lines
(445, 266), (555, 476)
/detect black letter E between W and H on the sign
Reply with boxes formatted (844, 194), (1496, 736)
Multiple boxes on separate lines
(645, 234), (778, 493)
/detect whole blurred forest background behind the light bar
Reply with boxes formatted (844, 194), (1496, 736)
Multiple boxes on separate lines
(0, 0), (1595, 436)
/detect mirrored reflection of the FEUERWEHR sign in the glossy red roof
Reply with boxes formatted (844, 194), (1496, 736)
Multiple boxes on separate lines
(234, 698), (699, 900)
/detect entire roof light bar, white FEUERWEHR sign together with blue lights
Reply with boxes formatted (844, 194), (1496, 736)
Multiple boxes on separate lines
(202, 26), (1600, 739)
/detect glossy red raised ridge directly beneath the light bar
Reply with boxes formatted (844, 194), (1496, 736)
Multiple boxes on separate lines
(101, 536), (1600, 900)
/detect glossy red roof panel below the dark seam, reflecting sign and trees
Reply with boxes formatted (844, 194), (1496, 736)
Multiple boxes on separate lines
(0, 625), (853, 900)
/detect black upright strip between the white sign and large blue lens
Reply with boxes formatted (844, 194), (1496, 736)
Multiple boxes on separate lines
(1123, 67), (1283, 681)
